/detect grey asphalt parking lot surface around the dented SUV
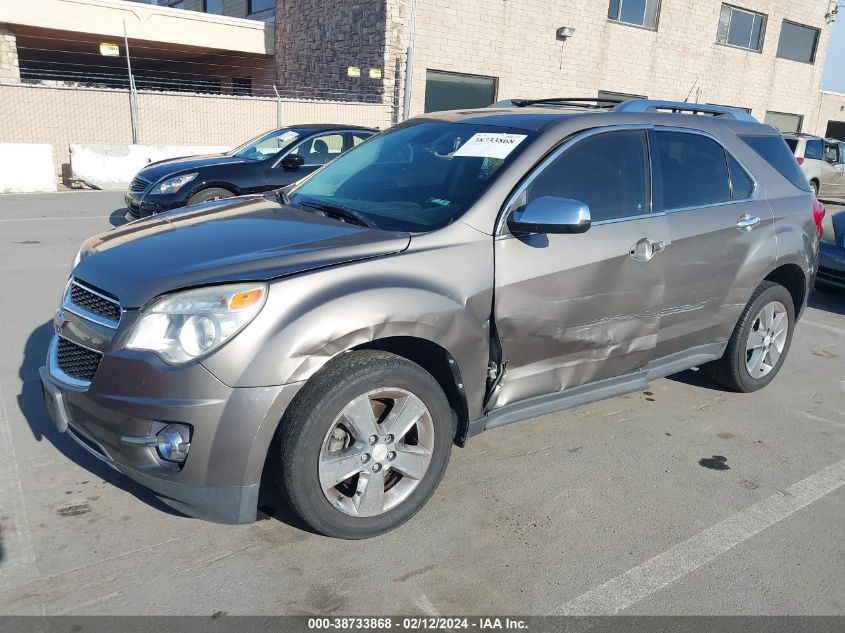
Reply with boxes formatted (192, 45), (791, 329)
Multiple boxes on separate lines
(0, 192), (845, 615)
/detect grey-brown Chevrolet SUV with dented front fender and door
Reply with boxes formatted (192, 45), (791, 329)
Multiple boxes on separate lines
(41, 100), (820, 538)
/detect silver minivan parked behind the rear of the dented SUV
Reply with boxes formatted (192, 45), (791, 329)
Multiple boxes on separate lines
(784, 134), (845, 198)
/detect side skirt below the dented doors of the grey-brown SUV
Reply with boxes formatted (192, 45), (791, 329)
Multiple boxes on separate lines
(467, 342), (728, 438)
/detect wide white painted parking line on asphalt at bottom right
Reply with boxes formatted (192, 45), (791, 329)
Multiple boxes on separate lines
(549, 459), (845, 615)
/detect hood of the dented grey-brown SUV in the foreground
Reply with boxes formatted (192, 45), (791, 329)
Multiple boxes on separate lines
(73, 196), (411, 308)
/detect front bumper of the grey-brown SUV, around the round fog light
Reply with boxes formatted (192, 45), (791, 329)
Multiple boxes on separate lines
(40, 346), (299, 523)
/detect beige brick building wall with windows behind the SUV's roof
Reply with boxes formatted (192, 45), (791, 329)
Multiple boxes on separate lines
(400, 0), (830, 124)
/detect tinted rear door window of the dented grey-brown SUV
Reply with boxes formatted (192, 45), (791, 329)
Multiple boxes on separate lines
(654, 131), (732, 211)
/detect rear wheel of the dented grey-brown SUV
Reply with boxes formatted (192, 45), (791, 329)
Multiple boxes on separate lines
(706, 281), (795, 393)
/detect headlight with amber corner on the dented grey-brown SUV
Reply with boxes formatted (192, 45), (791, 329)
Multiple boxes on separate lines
(126, 283), (267, 365)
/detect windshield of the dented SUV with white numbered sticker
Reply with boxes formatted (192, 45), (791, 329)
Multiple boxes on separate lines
(290, 120), (533, 232)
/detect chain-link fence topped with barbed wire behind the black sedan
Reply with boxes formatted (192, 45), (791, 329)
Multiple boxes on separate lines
(0, 30), (397, 184)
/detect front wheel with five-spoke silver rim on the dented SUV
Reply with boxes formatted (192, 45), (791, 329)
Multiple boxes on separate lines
(274, 350), (454, 539)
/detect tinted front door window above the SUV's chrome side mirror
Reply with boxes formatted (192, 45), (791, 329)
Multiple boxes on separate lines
(520, 130), (649, 222)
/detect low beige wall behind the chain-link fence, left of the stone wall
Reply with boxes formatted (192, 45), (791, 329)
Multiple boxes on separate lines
(0, 84), (392, 183)
